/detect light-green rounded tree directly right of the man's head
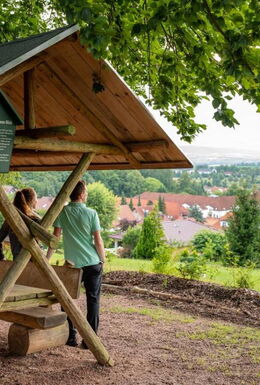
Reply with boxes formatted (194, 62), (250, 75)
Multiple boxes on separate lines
(87, 182), (117, 230)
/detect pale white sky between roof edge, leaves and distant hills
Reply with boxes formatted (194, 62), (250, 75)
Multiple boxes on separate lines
(152, 96), (260, 156)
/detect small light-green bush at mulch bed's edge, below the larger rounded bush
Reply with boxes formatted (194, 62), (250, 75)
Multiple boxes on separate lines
(177, 249), (206, 279)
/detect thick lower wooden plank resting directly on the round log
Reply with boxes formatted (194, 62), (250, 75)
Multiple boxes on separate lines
(0, 307), (67, 329)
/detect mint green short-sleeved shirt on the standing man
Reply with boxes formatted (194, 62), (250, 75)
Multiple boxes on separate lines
(53, 202), (101, 268)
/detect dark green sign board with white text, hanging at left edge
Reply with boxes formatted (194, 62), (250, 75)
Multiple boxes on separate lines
(0, 91), (22, 172)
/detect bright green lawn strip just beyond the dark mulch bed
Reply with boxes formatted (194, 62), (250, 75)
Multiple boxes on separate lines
(51, 253), (260, 291)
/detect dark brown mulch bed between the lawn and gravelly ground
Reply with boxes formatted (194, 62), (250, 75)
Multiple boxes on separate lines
(104, 271), (260, 327)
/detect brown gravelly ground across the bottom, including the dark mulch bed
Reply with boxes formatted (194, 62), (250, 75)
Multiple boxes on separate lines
(0, 272), (260, 385)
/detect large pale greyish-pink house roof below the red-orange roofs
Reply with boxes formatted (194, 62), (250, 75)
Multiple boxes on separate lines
(162, 219), (217, 244)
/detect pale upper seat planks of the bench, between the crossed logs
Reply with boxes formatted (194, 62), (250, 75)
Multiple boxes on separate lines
(5, 285), (52, 302)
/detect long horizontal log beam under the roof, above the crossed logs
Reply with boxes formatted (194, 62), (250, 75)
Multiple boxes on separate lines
(14, 136), (167, 155)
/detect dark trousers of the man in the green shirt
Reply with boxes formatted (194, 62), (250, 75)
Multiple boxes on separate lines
(64, 263), (103, 338)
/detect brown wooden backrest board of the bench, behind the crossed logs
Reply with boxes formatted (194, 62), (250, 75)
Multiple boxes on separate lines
(0, 261), (82, 301)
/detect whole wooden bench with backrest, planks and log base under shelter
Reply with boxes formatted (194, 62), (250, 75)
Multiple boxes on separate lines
(0, 261), (82, 355)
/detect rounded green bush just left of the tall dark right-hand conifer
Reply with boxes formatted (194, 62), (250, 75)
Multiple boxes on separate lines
(192, 230), (227, 261)
